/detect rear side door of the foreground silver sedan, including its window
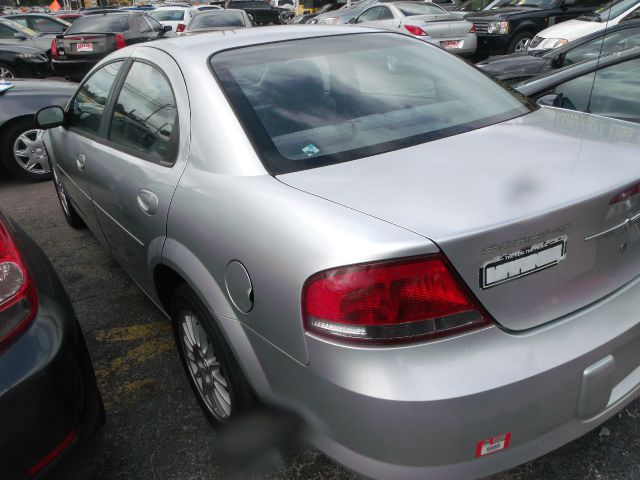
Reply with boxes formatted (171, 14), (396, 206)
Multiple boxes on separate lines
(91, 48), (190, 292)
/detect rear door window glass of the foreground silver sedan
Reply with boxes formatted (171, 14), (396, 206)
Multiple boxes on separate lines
(109, 62), (178, 161)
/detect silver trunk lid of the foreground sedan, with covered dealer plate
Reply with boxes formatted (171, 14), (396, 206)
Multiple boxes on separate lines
(278, 108), (640, 330)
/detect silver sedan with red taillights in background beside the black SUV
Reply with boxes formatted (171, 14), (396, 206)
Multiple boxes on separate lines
(349, 2), (478, 56)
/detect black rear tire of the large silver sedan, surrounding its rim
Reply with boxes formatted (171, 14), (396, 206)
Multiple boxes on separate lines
(171, 284), (257, 430)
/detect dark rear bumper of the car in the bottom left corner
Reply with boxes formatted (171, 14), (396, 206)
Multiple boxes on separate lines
(0, 226), (102, 479)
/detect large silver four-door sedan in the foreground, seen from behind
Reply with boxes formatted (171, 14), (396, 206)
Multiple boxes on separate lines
(37, 26), (640, 479)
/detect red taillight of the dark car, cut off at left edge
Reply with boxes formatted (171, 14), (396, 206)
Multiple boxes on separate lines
(0, 221), (38, 349)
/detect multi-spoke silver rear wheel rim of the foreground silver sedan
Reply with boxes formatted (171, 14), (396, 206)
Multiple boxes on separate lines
(180, 312), (231, 420)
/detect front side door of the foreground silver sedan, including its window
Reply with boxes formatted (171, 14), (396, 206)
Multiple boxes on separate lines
(49, 59), (124, 248)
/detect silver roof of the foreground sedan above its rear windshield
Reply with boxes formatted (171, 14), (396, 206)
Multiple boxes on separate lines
(143, 25), (382, 59)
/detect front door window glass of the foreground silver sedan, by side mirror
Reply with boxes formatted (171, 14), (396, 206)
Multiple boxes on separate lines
(68, 61), (122, 135)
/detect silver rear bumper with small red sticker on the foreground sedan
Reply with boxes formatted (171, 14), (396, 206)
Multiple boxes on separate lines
(234, 272), (640, 480)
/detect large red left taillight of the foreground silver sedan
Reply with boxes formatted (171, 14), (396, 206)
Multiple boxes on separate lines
(302, 255), (490, 343)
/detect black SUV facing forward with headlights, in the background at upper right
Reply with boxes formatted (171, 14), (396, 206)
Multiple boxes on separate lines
(465, 0), (602, 58)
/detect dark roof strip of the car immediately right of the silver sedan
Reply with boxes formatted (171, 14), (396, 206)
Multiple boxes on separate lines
(514, 47), (640, 95)
